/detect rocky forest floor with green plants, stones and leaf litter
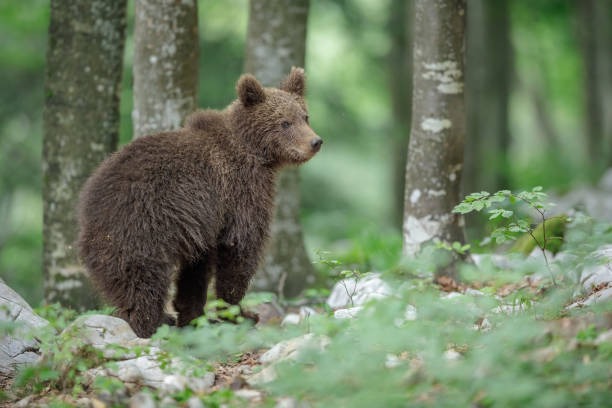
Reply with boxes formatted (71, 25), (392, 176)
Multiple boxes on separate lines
(0, 245), (612, 408)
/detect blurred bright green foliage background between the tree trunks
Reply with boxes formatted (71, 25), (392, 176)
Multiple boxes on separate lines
(0, 0), (601, 305)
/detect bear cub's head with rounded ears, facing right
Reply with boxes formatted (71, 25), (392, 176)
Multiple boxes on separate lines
(234, 68), (323, 166)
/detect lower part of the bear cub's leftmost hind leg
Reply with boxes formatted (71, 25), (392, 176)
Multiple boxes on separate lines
(113, 259), (175, 338)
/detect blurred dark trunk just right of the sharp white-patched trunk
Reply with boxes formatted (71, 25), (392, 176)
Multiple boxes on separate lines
(462, 0), (512, 194)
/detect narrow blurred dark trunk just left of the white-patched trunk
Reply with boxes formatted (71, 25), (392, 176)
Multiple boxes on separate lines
(389, 0), (413, 226)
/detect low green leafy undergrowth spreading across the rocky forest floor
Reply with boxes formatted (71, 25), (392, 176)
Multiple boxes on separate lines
(4, 190), (612, 407)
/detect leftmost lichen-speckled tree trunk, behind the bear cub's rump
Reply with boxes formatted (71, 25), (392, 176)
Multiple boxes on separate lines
(43, 0), (126, 309)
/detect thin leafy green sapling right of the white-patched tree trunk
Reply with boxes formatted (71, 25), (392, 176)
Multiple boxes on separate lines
(453, 186), (557, 286)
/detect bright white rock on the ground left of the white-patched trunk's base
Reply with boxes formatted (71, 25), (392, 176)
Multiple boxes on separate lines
(327, 273), (392, 309)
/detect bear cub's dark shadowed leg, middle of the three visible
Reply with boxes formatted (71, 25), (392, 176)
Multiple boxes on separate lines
(174, 254), (214, 327)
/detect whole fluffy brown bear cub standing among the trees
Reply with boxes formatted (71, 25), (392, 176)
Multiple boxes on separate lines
(78, 68), (322, 337)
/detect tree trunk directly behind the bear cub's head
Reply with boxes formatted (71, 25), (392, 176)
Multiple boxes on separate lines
(245, 0), (314, 296)
